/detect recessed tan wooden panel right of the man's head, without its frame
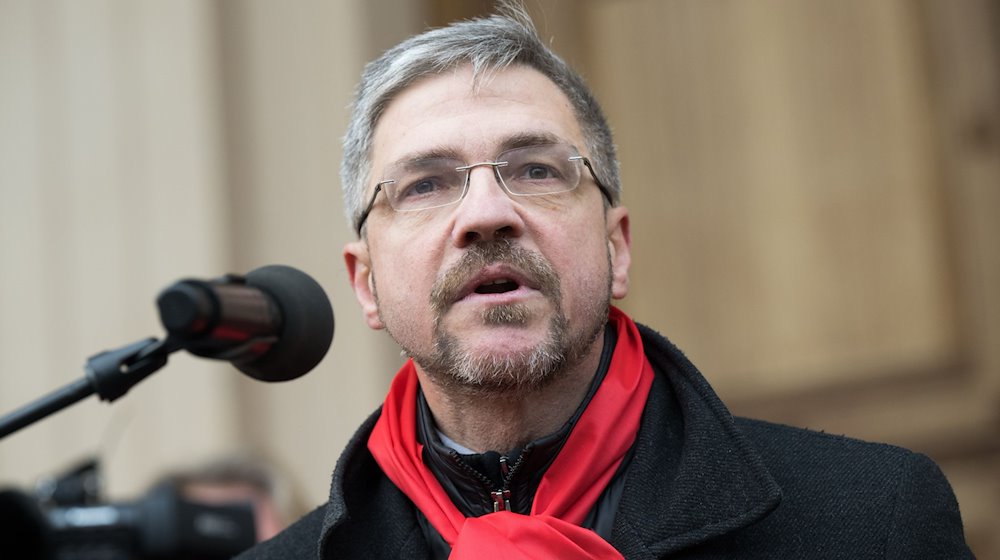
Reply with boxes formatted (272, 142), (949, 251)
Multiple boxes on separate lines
(590, 1), (959, 397)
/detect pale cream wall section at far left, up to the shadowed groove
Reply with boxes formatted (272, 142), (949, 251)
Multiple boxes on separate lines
(0, 1), (239, 493)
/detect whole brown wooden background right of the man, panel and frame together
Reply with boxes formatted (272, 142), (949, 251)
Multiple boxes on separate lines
(535, 0), (1000, 558)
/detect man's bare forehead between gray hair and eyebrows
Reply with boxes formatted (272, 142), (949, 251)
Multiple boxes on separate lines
(372, 66), (583, 171)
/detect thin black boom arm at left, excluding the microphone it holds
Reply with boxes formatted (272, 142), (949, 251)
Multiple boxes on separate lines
(0, 337), (182, 439)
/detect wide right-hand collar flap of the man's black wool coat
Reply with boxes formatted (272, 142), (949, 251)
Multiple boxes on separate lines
(612, 325), (781, 558)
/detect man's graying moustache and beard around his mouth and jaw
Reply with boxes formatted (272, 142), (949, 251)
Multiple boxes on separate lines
(373, 239), (611, 395)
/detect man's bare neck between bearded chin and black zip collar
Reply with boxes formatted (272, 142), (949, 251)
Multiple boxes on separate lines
(417, 330), (604, 453)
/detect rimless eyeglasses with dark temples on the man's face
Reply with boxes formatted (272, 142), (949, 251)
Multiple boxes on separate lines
(356, 144), (614, 235)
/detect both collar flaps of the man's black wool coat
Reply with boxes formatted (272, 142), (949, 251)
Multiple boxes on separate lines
(318, 325), (781, 558)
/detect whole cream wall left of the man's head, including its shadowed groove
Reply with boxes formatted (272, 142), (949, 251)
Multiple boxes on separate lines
(0, 0), (419, 506)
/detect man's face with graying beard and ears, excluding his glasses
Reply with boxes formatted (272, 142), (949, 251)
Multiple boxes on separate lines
(345, 66), (629, 388)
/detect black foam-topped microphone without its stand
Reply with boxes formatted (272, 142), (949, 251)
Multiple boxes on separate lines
(156, 265), (334, 381)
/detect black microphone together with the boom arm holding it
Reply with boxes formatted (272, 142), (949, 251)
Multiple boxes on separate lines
(0, 265), (334, 439)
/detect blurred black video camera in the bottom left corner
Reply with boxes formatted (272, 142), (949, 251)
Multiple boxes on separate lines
(0, 462), (256, 560)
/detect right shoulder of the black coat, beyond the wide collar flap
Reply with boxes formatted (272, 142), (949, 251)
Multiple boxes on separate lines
(736, 418), (972, 558)
